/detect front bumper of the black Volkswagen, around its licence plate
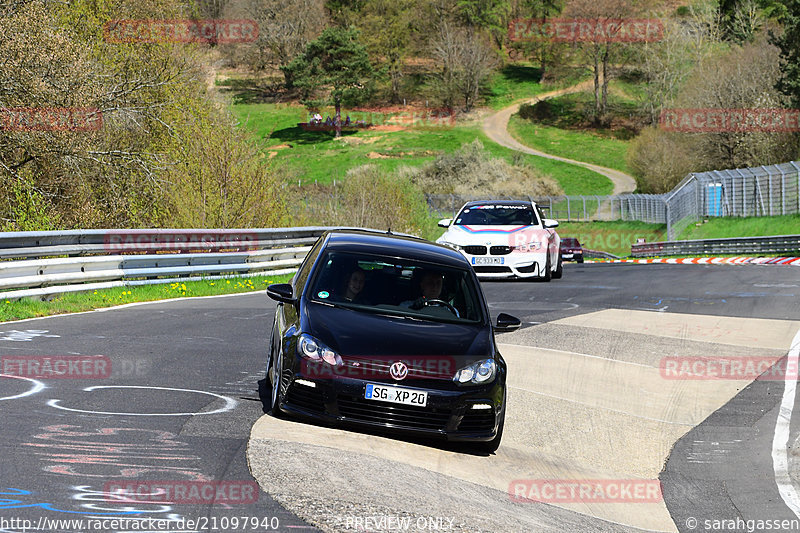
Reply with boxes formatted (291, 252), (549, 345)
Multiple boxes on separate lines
(281, 374), (505, 441)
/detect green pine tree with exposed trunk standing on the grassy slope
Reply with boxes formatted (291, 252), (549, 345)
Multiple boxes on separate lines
(283, 27), (374, 137)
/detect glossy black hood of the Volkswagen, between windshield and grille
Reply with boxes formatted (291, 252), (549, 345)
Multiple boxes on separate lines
(304, 302), (494, 358)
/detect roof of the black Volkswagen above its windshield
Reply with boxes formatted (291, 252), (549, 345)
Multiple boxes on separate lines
(318, 229), (470, 268)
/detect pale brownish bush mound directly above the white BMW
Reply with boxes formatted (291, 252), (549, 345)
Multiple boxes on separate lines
(404, 139), (563, 196)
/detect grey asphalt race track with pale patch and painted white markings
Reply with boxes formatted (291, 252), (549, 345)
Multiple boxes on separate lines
(0, 264), (800, 533)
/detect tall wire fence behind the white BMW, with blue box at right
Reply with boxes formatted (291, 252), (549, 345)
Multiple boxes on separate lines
(426, 161), (800, 239)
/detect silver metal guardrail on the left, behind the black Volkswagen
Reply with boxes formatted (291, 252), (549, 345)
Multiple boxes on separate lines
(0, 227), (332, 302)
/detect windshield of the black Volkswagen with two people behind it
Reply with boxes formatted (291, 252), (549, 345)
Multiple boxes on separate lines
(309, 252), (484, 323)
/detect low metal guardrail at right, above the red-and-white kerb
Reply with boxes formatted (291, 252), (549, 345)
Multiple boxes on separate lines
(631, 235), (800, 257)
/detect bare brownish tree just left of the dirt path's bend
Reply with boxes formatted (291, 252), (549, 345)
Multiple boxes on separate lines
(433, 23), (497, 111)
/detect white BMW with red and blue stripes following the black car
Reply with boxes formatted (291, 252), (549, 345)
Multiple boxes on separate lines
(436, 200), (562, 281)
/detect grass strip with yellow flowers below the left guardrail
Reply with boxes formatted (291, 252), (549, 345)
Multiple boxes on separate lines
(0, 275), (292, 322)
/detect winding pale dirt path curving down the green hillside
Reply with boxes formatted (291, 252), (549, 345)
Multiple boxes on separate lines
(483, 80), (636, 194)
